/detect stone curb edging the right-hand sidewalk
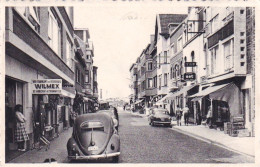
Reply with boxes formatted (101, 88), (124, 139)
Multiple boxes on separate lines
(171, 127), (255, 158)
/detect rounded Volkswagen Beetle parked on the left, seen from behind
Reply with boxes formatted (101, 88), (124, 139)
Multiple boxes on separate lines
(67, 113), (120, 162)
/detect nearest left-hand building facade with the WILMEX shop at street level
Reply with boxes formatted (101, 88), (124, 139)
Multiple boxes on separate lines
(5, 7), (75, 150)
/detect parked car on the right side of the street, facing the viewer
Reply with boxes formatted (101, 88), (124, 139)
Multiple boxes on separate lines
(148, 108), (172, 127)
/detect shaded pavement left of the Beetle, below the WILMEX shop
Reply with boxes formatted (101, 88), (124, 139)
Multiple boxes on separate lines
(7, 128), (73, 163)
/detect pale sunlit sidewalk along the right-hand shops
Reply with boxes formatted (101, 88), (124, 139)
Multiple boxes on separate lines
(132, 113), (255, 158)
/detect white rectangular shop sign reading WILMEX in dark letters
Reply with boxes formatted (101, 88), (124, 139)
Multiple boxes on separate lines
(32, 79), (62, 94)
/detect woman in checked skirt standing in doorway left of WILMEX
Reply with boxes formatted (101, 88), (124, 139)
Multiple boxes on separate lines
(14, 104), (29, 151)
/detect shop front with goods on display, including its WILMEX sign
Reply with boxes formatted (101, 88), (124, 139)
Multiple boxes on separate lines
(32, 79), (73, 147)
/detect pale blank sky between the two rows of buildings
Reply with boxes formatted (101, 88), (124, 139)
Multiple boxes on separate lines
(74, 2), (187, 99)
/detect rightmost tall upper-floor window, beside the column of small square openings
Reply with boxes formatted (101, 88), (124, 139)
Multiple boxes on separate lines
(223, 40), (233, 71)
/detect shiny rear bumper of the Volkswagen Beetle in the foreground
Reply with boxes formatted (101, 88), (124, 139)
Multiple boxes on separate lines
(68, 152), (120, 160)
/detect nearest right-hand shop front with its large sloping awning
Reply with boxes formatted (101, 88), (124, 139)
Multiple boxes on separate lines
(189, 83), (243, 127)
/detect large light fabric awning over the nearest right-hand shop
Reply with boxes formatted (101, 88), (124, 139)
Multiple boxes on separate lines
(190, 83), (242, 116)
